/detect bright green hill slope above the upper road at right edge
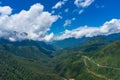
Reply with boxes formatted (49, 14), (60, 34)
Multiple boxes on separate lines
(93, 40), (120, 67)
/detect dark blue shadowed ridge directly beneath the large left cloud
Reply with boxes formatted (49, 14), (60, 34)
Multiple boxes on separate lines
(0, 39), (55, 57)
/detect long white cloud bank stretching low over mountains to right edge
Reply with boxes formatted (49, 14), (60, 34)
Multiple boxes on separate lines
(54, 19), (120, 40)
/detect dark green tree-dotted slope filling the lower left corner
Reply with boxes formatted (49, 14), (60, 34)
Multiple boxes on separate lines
(0, 51), (62, 80)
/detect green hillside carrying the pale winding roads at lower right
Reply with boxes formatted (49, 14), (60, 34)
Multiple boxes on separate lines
(54, 40), (120, 80)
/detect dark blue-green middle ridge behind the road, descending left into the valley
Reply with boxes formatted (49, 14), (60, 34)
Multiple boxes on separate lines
(52, 37), (111, 58)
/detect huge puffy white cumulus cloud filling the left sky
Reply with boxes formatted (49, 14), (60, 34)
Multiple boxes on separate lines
(0, 3), (59, 41)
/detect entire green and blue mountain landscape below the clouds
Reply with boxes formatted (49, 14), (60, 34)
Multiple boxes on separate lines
(0, 33), (120, 80)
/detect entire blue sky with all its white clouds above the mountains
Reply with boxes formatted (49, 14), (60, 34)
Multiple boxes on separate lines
(0, 0), (120, 42)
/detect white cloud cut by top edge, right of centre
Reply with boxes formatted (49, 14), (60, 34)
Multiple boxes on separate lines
(74, 0), (94, 8)
